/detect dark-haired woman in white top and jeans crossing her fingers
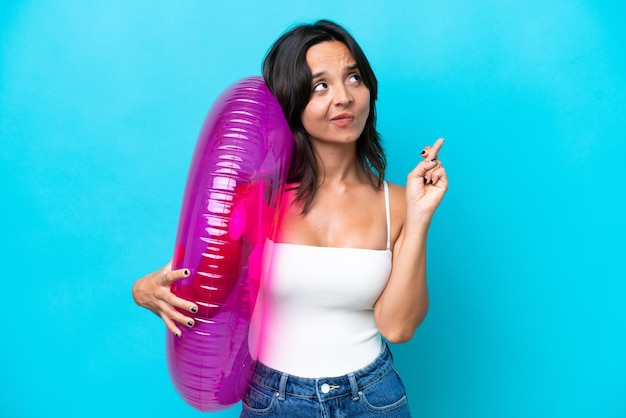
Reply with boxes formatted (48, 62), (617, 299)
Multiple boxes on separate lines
(133, 20), (448, 417)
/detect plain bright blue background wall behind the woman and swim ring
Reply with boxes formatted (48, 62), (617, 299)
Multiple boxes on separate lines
(0, 0), (626, 418)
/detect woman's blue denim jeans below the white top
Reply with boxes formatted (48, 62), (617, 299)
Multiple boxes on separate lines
(240, 345), (411, 418)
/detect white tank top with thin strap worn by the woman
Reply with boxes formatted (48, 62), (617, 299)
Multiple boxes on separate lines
(251, 182), (391, 378)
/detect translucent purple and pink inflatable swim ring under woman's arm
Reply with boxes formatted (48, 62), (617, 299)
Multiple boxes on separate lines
(166, 77), (294, 411)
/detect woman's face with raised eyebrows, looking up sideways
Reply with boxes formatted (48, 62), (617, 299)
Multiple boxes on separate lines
(302, 41), (370, 145)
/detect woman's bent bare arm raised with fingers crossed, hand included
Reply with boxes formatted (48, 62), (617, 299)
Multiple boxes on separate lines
(374, 138), (448, 343)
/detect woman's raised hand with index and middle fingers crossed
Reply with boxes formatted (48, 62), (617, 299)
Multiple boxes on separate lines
(406, 138), (448, 218)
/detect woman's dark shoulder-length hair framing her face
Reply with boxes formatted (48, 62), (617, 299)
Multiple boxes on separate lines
(263, 20), (387, 212)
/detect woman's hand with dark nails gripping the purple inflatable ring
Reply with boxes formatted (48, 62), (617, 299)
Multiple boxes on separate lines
(133, 260), (198, 337)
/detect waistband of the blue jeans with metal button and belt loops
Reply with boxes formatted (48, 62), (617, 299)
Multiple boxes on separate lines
(247, 344), (393, 401)
